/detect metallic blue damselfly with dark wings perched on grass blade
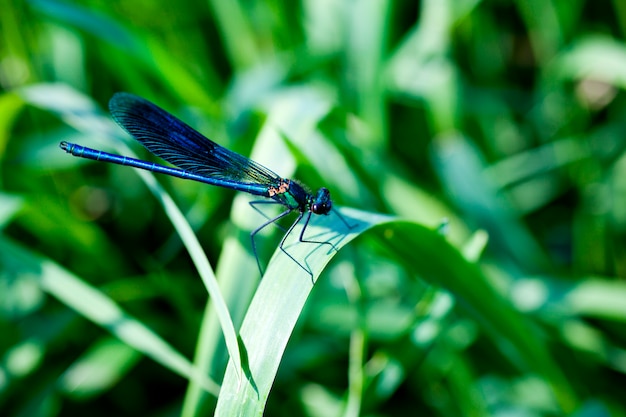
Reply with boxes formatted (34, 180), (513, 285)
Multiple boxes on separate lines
(60, 93), (353, 276)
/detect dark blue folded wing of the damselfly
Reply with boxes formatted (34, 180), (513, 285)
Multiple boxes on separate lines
(109, 93), (280, 184)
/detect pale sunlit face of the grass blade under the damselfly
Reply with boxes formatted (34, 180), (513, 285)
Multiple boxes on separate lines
(215, 209), (391, 416)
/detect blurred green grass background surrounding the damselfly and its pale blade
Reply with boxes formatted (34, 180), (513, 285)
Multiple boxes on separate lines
(0, 0), (626, 416)
